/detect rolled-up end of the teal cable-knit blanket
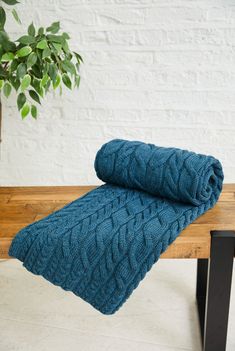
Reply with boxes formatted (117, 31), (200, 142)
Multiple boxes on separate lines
(95, 139), (223, 205)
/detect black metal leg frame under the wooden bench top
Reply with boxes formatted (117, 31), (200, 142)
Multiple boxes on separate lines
(196, 231), (235, 351)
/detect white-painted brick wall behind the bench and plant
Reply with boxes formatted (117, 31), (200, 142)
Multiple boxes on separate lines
(0, 0), (235, 185)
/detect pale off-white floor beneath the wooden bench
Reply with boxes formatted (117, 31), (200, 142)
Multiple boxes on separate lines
(0, 260), (235, 351)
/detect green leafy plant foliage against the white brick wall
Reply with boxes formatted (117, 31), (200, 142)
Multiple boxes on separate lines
(0, 0), (82, 118)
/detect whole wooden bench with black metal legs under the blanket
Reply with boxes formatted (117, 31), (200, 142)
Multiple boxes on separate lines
(0, 184), (235, 351)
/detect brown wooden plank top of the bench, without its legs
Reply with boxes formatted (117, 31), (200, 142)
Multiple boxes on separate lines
(0, 184), (235, 259)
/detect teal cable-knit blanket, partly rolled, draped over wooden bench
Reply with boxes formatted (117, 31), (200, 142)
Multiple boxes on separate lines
(9, 140), (223, 314)
